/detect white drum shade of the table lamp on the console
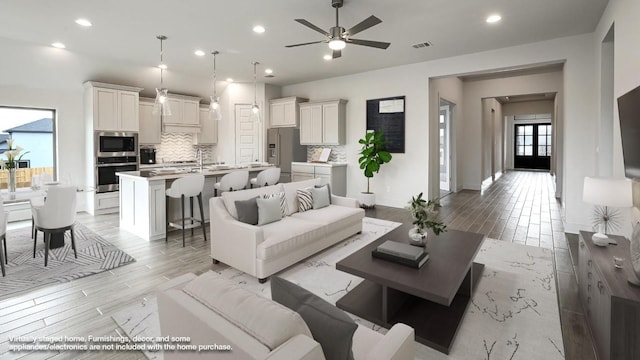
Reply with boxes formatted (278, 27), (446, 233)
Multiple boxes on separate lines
(582, 176), (633, 207)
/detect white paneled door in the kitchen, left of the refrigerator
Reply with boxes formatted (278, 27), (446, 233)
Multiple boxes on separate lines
(236, 105), (260, 164)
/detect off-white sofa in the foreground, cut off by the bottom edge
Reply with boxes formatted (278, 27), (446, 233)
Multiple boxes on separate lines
(157, 272), (415, 360)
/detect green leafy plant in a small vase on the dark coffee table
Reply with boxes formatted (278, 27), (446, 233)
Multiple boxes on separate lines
(407, 193), (447, 247)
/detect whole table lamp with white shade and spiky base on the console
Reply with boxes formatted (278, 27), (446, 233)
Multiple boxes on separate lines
(582, 176), (633, 246)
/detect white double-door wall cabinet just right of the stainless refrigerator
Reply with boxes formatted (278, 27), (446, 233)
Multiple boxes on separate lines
(300, 100), (347, 145)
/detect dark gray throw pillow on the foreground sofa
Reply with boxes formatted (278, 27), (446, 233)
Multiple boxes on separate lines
(271, 276), (358, 360)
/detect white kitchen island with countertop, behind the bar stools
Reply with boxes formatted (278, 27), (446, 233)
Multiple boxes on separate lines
(116, 166), (270, 240)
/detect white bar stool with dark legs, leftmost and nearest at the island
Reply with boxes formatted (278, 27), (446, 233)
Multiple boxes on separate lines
(165, 174), (207, 247)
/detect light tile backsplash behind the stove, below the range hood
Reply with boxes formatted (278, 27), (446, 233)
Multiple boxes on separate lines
(155, 133), (214, 163)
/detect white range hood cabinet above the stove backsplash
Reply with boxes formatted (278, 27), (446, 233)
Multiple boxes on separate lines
(162, 94), (200, 133)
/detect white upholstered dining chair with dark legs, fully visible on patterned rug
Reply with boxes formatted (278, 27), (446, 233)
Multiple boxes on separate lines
(31, 185), (78, 266)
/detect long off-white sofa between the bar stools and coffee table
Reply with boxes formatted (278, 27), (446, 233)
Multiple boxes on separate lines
(209, 179), (364, 282)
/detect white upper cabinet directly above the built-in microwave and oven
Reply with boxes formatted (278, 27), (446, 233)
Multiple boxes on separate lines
(84, 81), (142, 132)
